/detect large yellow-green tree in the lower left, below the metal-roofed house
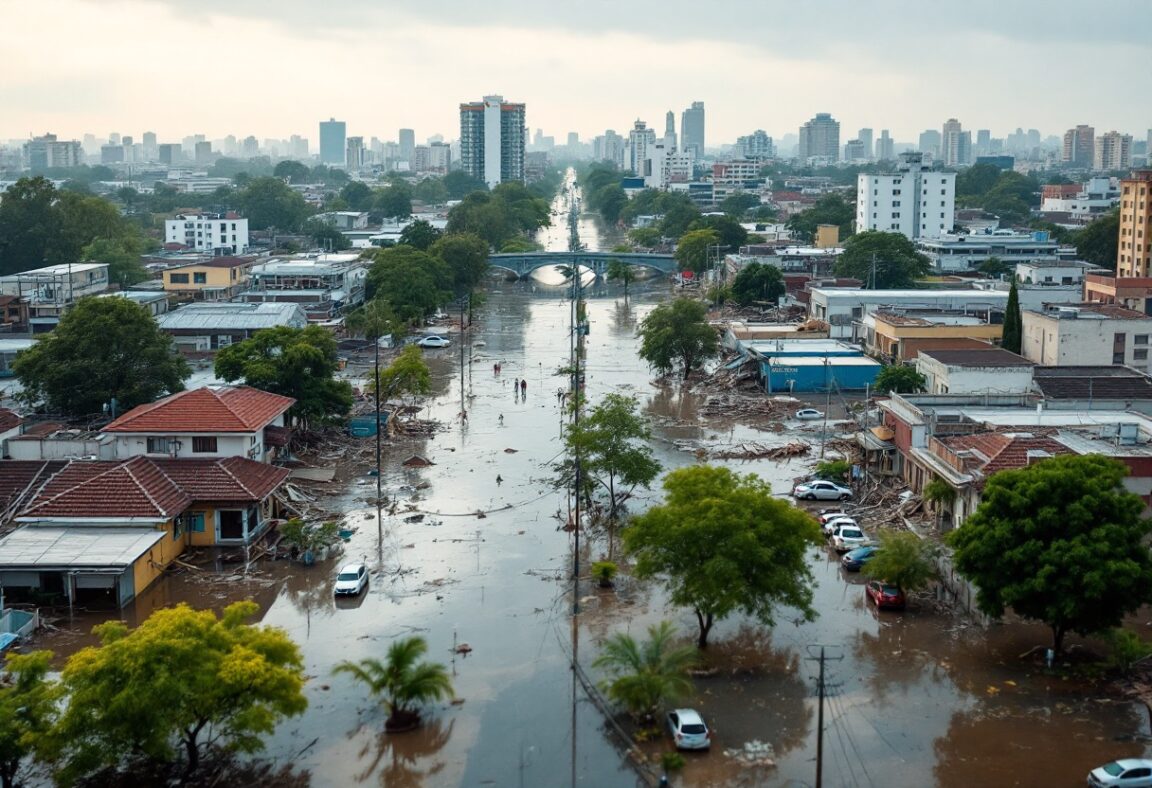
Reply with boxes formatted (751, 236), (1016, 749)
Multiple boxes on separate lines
(52, 601), (308, 786)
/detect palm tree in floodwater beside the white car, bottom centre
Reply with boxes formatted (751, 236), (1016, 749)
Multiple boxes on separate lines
(592, 621), (697, 721)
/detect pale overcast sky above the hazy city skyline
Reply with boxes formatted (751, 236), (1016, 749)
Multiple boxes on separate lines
(0, 0), (1152, 151)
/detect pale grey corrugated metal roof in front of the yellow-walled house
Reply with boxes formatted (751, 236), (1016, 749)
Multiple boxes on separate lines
(0, 525), (168, 569)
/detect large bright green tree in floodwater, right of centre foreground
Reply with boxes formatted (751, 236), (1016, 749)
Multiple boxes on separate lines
(624, 465), (821, 649)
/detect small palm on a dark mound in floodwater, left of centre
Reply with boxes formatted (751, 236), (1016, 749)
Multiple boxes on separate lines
(334, 637), (454, 733)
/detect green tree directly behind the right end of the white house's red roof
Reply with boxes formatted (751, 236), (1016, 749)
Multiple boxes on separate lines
(215, 326), (353, 427)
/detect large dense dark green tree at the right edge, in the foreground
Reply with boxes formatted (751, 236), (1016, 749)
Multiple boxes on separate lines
(948, 454), (1152, 653)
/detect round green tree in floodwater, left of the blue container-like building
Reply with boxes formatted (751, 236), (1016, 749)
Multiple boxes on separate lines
(639, 298), (720, 379)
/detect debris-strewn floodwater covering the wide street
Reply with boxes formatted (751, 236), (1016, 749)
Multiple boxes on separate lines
(31, 178), (1149, 788)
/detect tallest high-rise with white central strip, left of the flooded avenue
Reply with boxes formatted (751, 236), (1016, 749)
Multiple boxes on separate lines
(460, 96), (528, 188)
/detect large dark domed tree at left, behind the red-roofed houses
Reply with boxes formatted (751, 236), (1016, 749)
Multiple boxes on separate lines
(13, 297), (191, 418)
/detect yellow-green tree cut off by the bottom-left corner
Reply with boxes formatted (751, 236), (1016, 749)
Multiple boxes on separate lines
(0, 651), (60, 788)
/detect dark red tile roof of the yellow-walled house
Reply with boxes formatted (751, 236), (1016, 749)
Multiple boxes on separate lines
(16, 457), (289, 520)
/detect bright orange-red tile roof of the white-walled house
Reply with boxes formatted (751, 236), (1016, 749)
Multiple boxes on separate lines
(104, 386), (296, 433)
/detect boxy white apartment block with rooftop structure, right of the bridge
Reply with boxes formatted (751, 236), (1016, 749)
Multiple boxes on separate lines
(856, 153), (956, 240)
